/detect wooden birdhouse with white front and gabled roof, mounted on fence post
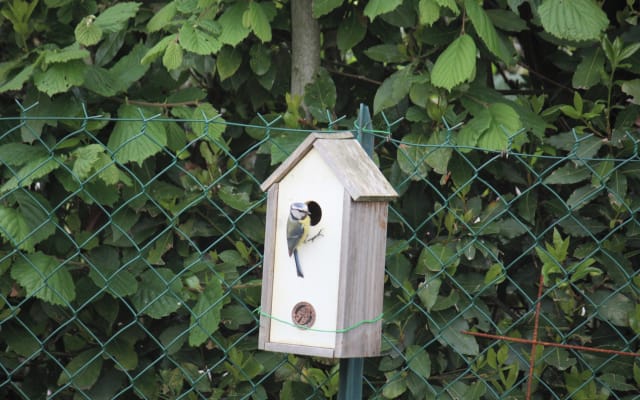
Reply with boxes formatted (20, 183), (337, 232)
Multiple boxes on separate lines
(258, 132), (398, 358)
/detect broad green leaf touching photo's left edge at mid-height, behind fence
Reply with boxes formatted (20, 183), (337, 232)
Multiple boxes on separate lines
(0, 192), (57, 252)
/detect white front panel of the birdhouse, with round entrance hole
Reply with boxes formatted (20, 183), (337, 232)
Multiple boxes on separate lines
(270, 149), (344, 348)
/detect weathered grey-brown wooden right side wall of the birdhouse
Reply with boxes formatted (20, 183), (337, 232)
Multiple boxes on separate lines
(334, 192), (388, 358)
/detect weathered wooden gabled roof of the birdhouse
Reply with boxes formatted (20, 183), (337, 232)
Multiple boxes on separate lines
(260, 132), (398, 201)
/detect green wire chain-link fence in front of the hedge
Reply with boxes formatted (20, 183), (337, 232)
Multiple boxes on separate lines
(0, 104), (640, 399)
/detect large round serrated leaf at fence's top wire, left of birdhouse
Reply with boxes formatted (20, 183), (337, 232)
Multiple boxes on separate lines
(107, 104), (167, 164)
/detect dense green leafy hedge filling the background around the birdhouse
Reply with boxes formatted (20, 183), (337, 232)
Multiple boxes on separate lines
(0, 0), (640, 399)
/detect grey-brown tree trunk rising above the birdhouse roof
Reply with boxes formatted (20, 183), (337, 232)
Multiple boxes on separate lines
(291, 0), (320, 109)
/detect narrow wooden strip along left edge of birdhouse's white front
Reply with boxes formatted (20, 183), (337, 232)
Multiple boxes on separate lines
(258, 183), (278, 350)
